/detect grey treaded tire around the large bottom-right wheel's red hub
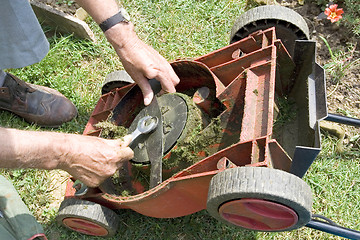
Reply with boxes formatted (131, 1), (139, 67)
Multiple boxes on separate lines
(207, 167), (312, 232)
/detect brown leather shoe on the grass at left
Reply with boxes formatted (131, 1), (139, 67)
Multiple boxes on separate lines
(0, 73), (77, 127)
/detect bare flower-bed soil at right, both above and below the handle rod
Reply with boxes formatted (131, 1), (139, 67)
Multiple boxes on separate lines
(281, 0), (360, 150)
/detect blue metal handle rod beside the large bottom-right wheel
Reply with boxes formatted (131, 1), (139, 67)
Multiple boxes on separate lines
(306, 219), (360, 239)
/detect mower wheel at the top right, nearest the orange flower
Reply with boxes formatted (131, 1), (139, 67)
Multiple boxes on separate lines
(230, 5), (309, 55)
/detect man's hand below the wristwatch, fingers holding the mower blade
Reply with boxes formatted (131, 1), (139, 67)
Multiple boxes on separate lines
(105, 23), (180, 105)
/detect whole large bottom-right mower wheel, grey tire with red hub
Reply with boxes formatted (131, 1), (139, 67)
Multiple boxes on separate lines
(207, 167), (312, 232)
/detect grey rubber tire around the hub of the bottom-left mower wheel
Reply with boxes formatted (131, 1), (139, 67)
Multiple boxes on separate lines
(56, 198), (120, 237)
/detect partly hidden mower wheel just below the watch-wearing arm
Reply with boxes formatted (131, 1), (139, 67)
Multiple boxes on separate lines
(101, 70), (134, 94)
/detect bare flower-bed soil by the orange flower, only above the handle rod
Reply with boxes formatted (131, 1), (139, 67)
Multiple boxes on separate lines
(282, 0), (360, 122)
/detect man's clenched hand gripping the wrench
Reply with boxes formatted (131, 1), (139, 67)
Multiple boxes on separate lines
(59, 136), (134, 187)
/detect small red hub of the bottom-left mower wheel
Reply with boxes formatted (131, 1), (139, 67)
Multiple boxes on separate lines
(63, 217), (109, 236)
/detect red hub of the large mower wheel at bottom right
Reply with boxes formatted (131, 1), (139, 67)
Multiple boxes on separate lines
(219, 198), (298, 231)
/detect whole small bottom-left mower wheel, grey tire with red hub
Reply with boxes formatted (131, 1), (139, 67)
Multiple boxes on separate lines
(56, 198), (119, 237)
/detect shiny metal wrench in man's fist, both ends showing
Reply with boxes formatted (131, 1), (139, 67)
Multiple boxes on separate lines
(73, 116), (159, 196)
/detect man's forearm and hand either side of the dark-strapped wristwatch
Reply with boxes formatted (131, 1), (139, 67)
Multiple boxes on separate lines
(76, 0), (180, 105)
